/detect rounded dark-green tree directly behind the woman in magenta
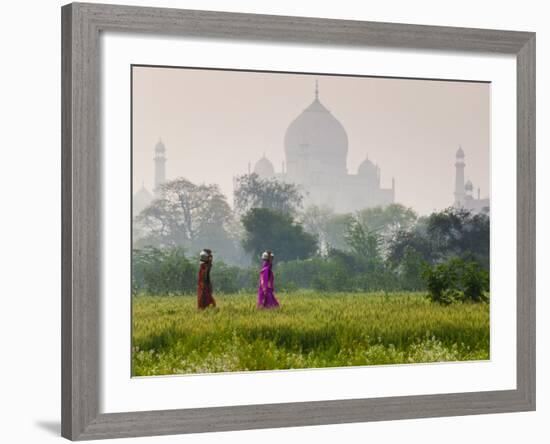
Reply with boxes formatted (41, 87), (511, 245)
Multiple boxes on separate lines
(241, 208), (317, 261)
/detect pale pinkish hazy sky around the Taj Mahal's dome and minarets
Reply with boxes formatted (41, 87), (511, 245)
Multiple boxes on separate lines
(133, 67), (490, 214)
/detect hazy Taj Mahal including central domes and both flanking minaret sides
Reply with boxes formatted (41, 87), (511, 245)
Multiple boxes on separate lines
(132, 82), (490, 216)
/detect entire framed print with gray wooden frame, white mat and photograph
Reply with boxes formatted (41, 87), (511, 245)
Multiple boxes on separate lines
(62, 3), (535, 440)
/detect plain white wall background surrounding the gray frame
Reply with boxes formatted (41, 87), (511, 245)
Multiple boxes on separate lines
(0, 0), (550, 444)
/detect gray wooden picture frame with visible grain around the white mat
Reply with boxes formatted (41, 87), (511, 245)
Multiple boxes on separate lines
(61, 3), (535, 440)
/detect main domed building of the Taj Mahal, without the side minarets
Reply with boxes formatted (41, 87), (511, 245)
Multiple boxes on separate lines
(248, 83), (395, 213)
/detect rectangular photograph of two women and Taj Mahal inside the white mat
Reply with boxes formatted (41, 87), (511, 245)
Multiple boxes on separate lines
(128, 65), (492, 377)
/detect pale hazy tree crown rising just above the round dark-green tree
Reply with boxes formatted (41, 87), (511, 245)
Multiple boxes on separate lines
(234, 173), (303, 214)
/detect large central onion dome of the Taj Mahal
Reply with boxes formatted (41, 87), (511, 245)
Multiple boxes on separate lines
(285, 85), (348, 172)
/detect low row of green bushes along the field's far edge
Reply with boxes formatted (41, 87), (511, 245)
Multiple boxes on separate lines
(132, 247), (489, 296)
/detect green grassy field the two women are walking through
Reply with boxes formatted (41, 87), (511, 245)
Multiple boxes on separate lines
(132, 291), (489, 376)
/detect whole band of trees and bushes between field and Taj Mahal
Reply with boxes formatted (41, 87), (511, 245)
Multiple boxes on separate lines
(134, 174), (489, 302)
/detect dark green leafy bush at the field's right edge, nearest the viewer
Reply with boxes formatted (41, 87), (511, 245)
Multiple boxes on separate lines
(422, 258), (489, 304)
